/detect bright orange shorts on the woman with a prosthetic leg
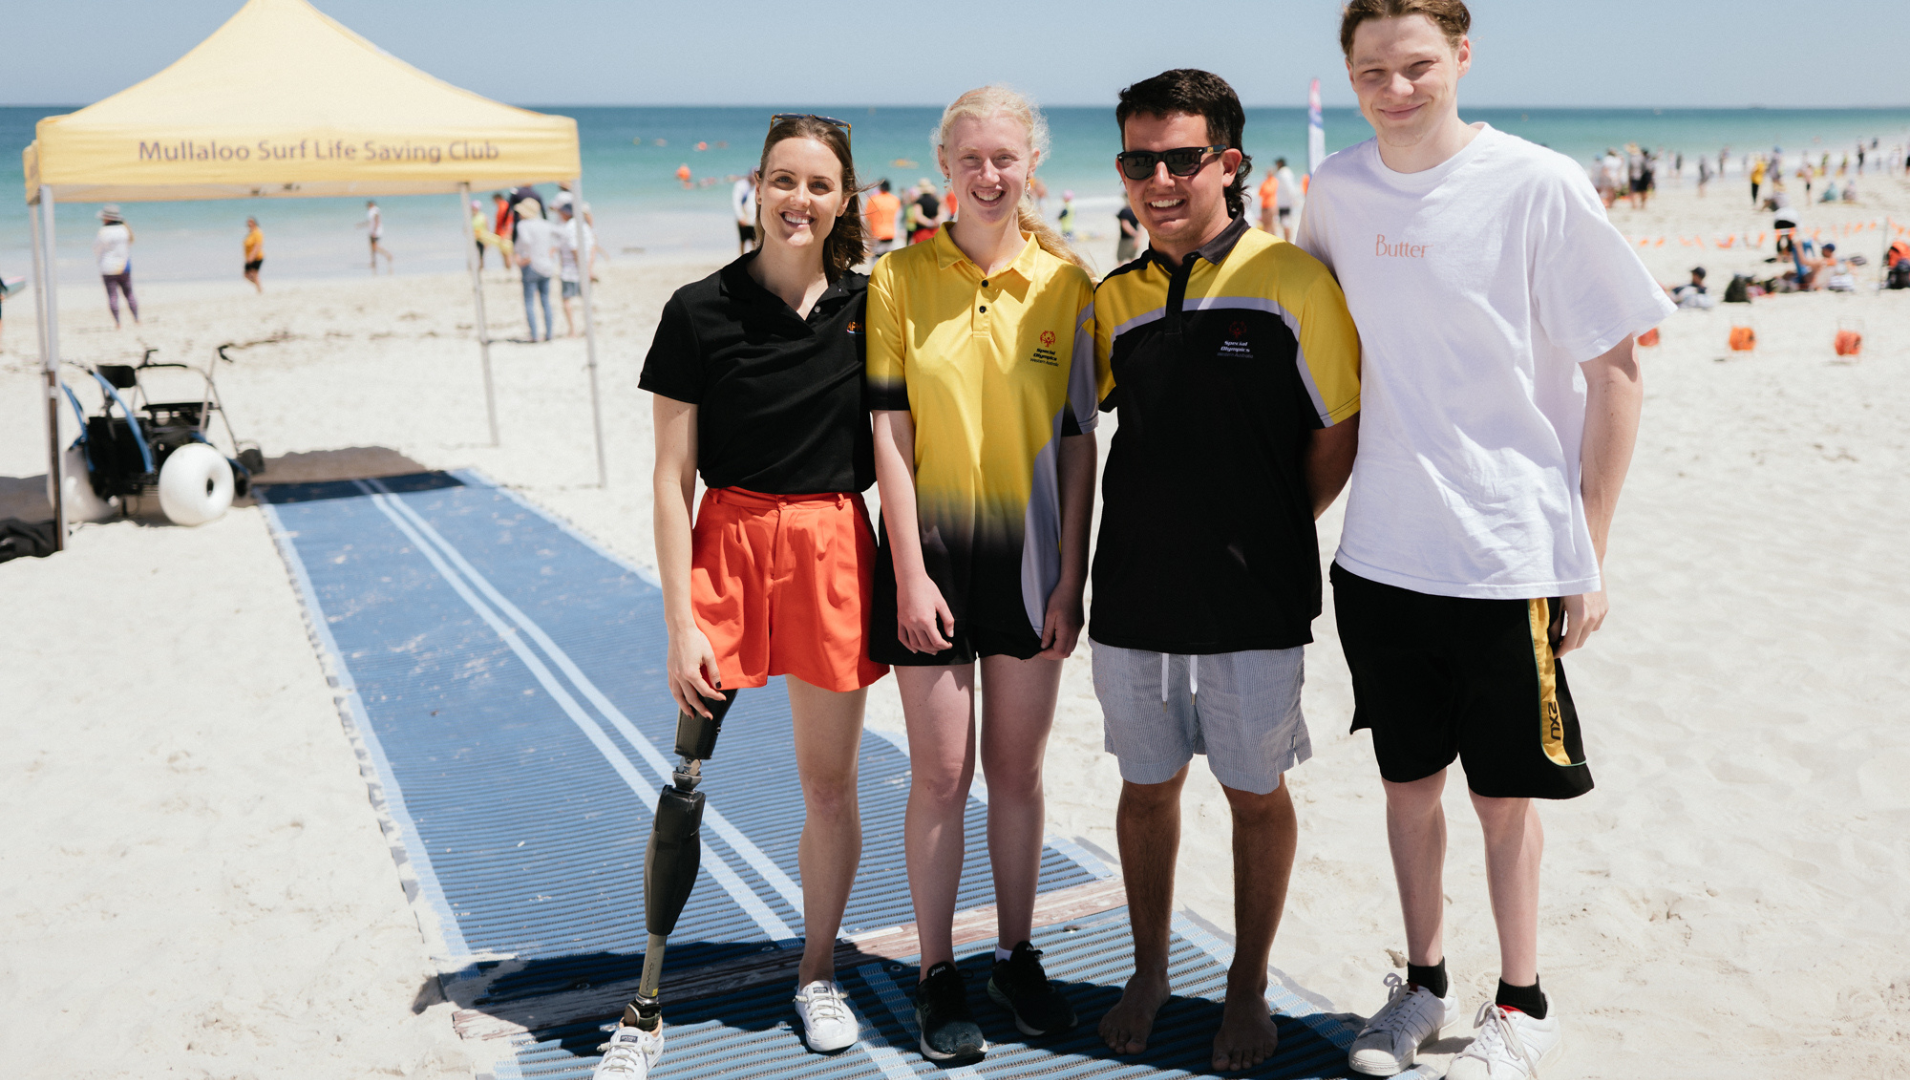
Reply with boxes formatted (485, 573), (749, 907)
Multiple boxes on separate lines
(690, 487), (888, 690)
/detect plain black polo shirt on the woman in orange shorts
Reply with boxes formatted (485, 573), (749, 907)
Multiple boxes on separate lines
(638, 252), (875, 495)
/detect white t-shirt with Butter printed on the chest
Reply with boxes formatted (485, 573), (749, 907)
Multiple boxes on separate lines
(1297, 124), (1675, 600)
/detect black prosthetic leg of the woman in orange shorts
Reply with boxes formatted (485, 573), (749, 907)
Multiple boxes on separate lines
(623, 690), (735, 1034)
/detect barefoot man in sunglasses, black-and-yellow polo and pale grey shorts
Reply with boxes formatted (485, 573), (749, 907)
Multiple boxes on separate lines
(1089, 71), (1360, 1070)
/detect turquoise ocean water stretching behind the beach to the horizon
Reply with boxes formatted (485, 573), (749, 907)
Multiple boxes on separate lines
(0, 107), (1910, 283)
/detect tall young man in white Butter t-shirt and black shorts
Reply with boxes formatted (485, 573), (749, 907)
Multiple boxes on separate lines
(1299, 0), (1673, 1080)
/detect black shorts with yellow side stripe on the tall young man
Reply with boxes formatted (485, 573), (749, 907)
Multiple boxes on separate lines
(1331, 562), (1591, 799)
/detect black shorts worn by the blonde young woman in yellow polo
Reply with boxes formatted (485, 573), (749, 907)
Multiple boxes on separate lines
(869, 508), (1041, 667)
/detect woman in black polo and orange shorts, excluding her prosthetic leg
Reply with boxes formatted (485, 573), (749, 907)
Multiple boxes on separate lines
(637, 117), (888, 1051)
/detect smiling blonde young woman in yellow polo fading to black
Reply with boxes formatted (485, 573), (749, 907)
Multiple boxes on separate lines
(867, 86), (1096, 1061)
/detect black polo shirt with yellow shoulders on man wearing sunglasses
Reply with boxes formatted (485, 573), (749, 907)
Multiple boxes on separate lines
(1092, 210), (1360, 654)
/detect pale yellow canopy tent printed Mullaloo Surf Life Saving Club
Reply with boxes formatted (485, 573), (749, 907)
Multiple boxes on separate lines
(25, 0), (604, 543)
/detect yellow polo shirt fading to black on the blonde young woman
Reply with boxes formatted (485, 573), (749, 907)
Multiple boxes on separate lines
(867, 227), (1096, 637)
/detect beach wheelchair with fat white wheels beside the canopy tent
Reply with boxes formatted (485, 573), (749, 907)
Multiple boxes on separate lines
(61, 346), (265, 526)
